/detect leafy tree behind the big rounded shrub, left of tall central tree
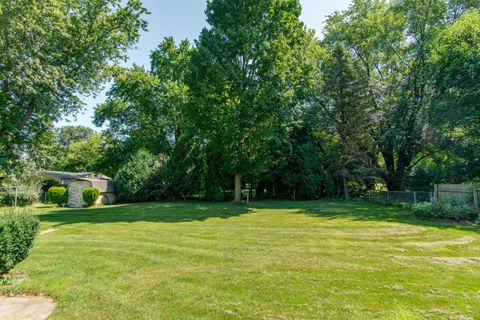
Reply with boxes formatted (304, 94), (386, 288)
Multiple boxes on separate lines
(95, 38), (192, 154)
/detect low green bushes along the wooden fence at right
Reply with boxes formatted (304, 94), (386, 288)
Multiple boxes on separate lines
(413, 201), (479, 222)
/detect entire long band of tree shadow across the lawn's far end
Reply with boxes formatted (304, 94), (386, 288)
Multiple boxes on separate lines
(39, 200), (480, 232)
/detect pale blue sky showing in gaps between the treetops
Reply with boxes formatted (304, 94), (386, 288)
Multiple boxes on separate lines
(57, 0), (350, 130)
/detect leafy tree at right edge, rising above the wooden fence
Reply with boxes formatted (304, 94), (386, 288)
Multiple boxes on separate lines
(431, 9), (480, 183)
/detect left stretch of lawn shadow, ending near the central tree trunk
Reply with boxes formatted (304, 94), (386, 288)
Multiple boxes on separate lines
(39, 202), (250, 227)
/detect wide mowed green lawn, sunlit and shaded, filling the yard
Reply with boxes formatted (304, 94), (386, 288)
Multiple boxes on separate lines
(0, 201), (480, 320)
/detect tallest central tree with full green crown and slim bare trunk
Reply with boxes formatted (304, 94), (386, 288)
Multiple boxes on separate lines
(189, 0), (313, 201)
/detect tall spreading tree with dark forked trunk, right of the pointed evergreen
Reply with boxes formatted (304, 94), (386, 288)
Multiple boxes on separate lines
(325, 0), (478, 190)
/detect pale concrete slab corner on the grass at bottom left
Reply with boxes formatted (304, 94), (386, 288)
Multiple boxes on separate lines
(0, 297), (55, 320)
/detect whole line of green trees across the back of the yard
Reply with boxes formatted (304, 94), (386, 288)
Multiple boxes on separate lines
(0, 0), (480, 201)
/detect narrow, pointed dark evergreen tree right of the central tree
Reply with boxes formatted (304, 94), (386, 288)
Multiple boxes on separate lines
(317, 44), (374, 199)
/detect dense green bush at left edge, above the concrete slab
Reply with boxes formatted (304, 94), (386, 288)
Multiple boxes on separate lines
(0, 209), (40, 275)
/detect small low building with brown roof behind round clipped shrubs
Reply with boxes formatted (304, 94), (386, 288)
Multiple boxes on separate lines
(43, 171), (117, 208)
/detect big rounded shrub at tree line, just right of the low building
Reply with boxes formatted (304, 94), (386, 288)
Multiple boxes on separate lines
(114, 150), (156, 202)
